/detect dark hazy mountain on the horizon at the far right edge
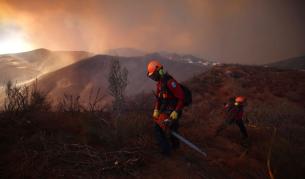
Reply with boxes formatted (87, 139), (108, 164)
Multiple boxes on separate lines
(266, 56), (305, 69)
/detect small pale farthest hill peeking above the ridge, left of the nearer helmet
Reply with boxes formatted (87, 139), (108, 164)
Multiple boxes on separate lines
(105, 48), (146, 57)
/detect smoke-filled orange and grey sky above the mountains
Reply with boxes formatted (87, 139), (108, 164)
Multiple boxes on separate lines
(0, 0), (305, 64)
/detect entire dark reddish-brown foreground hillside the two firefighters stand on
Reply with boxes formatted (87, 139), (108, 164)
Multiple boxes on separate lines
(0, 65), (305, 179)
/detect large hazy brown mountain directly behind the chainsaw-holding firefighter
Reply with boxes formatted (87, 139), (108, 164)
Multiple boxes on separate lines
(39, 54), (209, 103)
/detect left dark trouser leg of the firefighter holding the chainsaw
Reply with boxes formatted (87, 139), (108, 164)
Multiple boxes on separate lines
(154, 123), (170, 155)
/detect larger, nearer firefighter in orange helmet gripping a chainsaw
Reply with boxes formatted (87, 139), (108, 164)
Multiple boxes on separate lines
(147, 60), (184, 155)
